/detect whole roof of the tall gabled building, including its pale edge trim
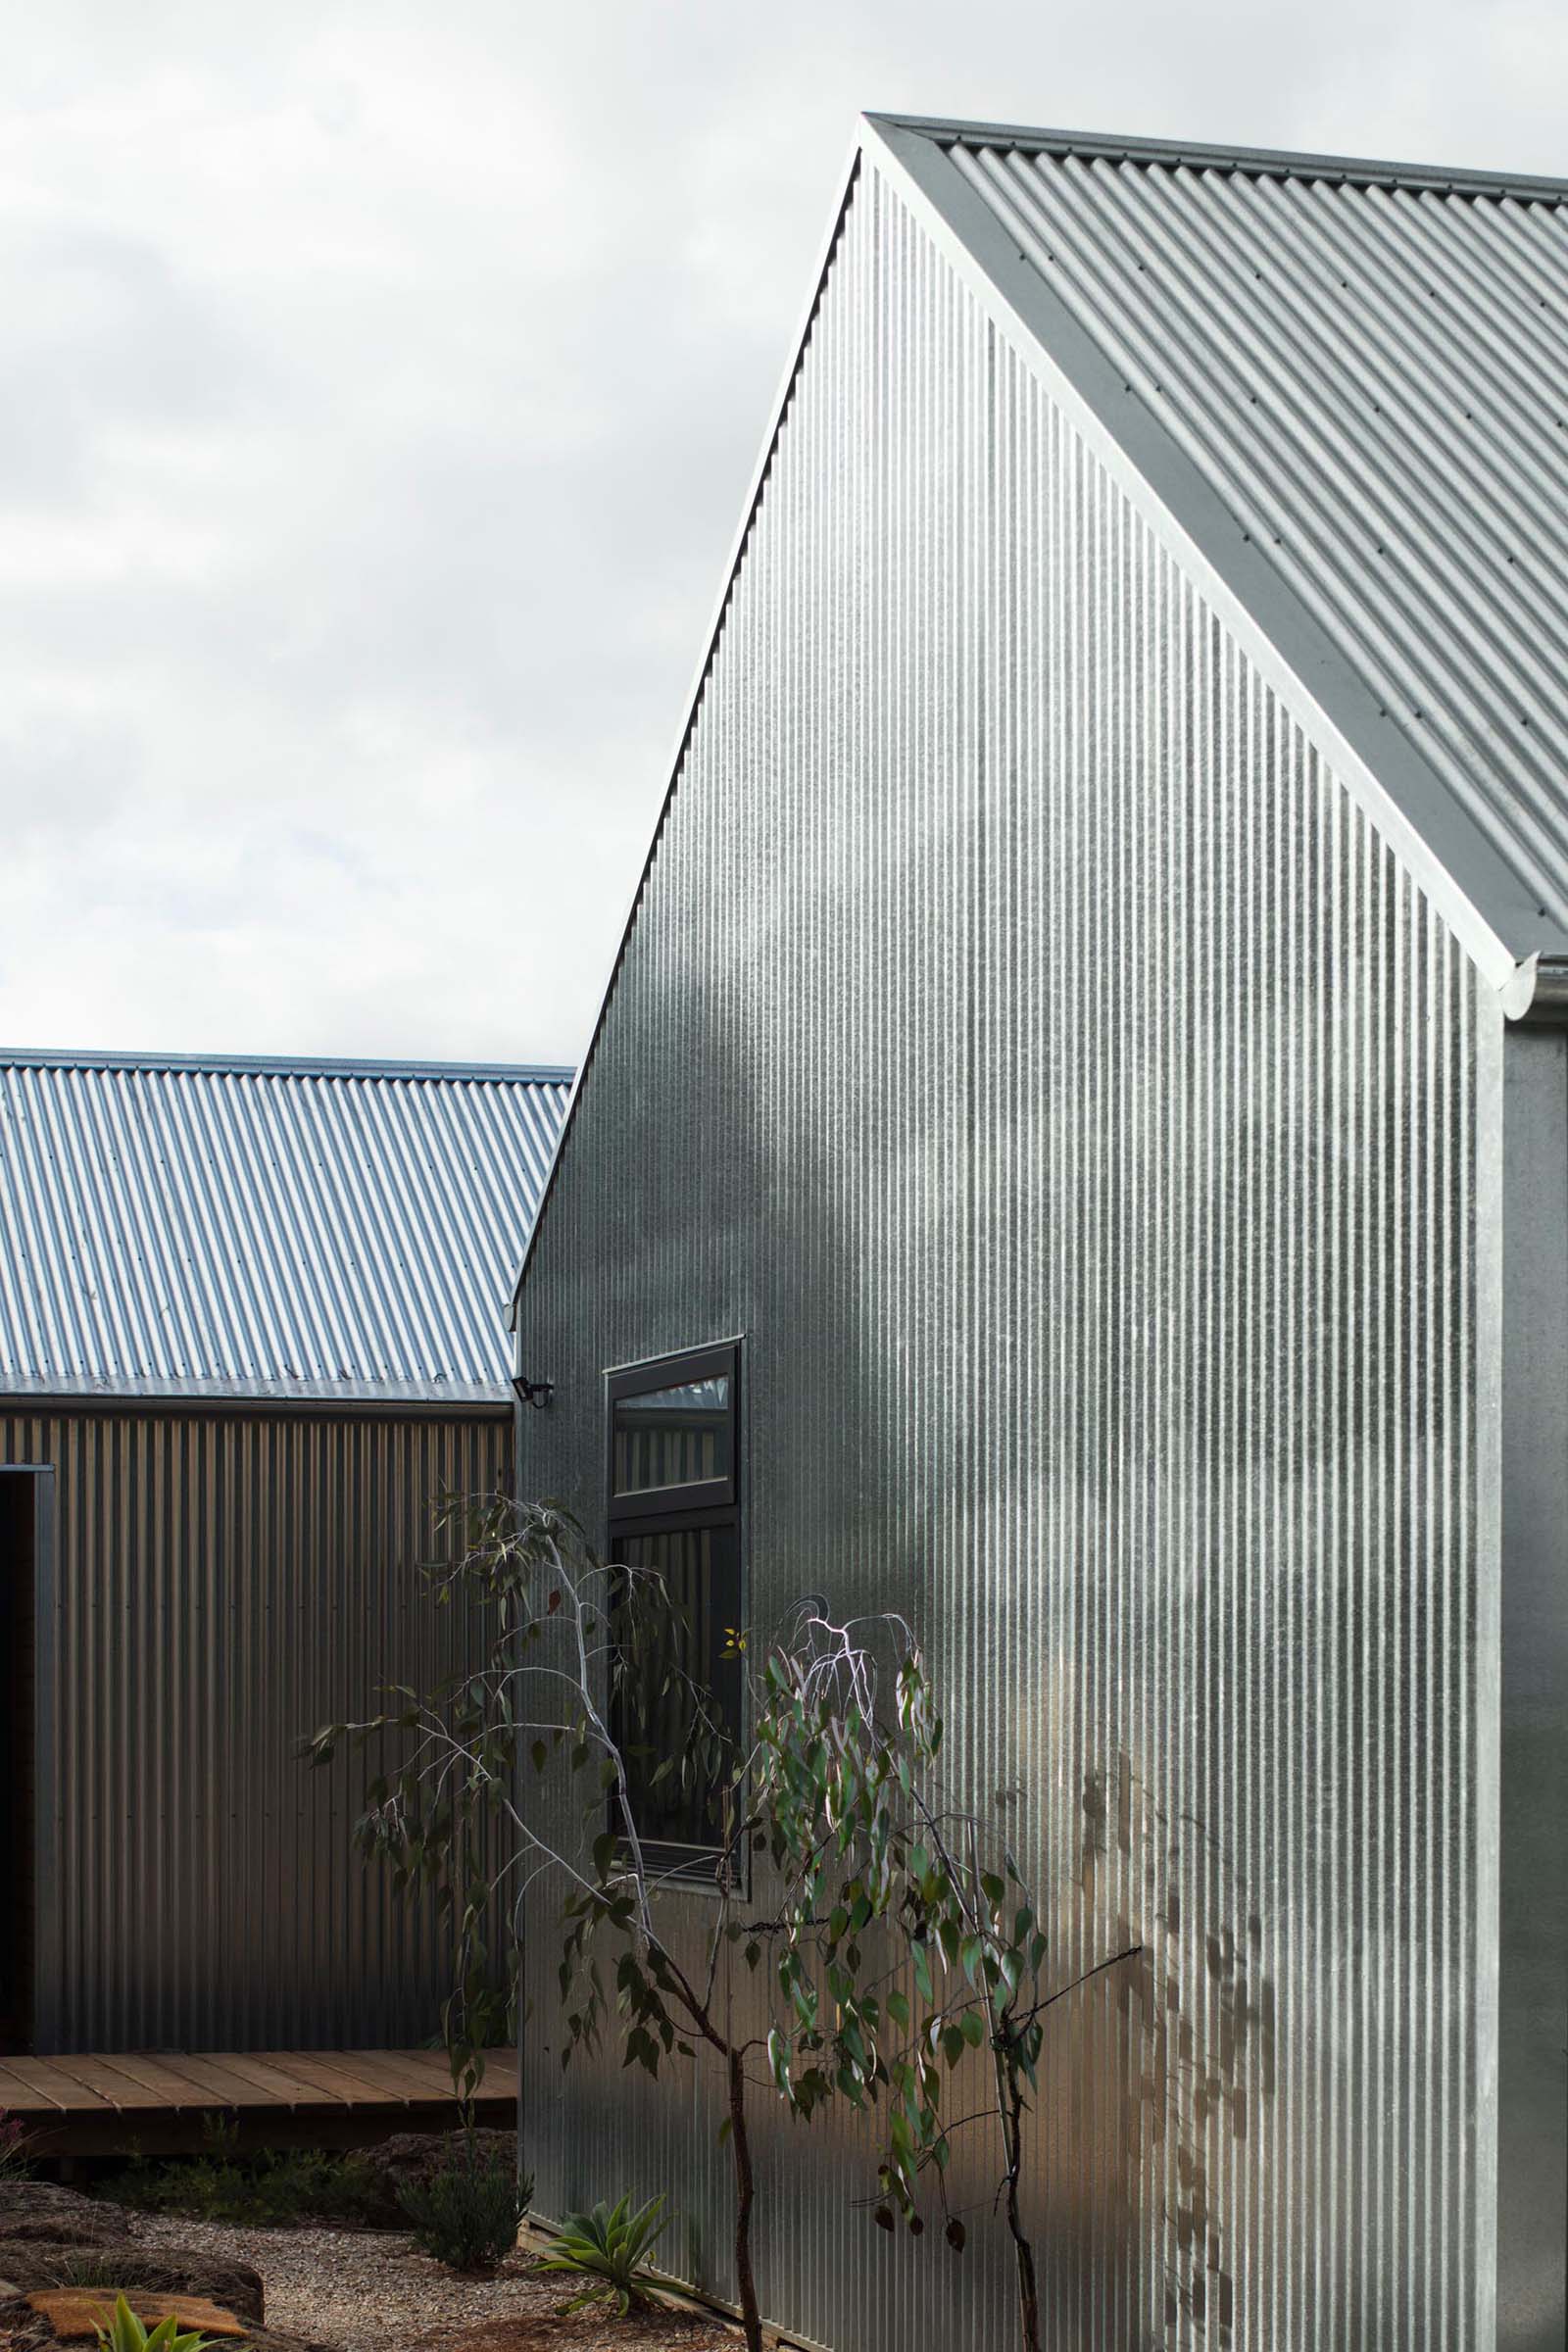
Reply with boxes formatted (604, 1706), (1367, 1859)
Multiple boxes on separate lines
(513, 116), (1568, 1305)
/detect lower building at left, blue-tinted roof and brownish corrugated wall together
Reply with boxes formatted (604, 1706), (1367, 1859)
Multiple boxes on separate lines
(0, 1052), (571, 2053)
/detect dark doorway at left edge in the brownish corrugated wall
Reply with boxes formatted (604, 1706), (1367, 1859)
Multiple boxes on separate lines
(0, 1470), (47, 2051)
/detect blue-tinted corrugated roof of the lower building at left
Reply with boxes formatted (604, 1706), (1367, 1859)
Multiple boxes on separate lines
(0, 1049), (571, 1404)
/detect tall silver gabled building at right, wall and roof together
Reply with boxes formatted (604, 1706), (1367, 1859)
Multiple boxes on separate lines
(514, 118), (1568, 2352)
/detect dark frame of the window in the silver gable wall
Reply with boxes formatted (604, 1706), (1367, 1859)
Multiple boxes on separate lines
(604, 1339), (748, 1891)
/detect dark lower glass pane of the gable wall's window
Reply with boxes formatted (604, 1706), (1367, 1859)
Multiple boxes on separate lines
(613, 1527), (741, 1853)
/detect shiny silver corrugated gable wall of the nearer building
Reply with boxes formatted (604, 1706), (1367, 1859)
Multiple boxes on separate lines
(519, 161), (1499, 2352)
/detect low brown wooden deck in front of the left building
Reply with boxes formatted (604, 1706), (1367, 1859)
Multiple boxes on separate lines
(0, 2051), (517, 2157)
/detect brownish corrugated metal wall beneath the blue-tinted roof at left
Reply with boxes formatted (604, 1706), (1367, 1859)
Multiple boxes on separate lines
(0, 1406), (511, 2051)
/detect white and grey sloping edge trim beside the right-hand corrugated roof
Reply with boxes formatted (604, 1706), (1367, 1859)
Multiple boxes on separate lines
(865, 118), (1568, 1009)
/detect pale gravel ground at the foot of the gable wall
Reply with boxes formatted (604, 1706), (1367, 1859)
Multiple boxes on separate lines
(124, 2213), (736, 2352)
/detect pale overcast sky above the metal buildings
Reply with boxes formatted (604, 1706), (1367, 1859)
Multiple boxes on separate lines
(0, 0), (1568, 1060)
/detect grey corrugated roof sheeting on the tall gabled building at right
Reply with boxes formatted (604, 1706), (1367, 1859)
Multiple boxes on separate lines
(883, 122), (1568, 957)
